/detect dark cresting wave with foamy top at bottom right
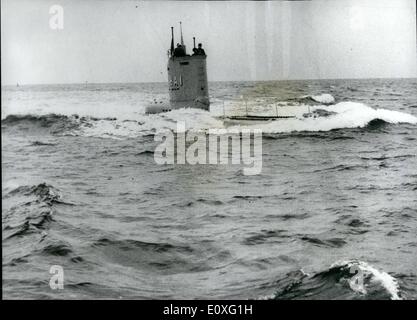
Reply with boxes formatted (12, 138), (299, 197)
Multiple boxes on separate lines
(265, 260), (404, 300)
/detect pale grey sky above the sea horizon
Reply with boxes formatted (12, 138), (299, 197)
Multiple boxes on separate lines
(1, 0), (417, 84)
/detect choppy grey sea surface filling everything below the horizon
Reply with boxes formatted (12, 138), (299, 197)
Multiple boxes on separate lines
(1, 79), (417, 299)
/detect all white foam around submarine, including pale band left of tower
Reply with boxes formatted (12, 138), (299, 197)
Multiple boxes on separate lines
(2, 86), (417, 138)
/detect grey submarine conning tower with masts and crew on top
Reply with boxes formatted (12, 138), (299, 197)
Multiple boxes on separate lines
(145, 22), (210, 114)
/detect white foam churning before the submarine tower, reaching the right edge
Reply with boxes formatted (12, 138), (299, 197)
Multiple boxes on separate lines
(65, 102), (417, 138)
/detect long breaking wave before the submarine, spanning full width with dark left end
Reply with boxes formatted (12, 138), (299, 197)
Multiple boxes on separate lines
(2, 100), (417, 139)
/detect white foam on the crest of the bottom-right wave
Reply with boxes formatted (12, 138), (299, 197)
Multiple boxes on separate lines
(330, 261), (401, 300)
